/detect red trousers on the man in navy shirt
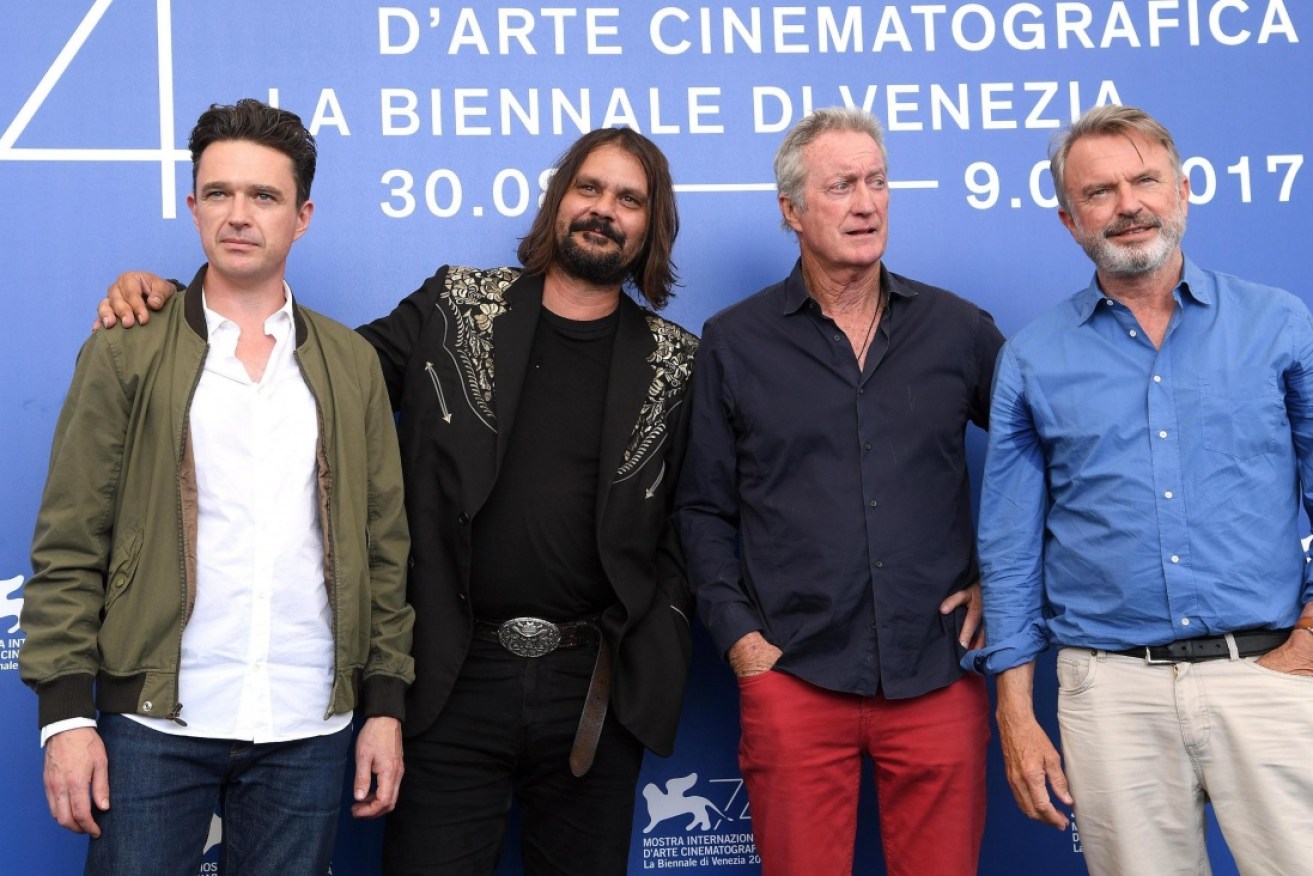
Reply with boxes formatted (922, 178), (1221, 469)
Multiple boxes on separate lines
(739, 671), (989, 876)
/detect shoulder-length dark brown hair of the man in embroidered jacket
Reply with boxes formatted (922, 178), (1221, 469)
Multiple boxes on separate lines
(516, 127), (679, 310)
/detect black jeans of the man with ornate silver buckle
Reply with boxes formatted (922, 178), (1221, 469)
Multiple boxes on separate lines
(383, 640), (643, 876)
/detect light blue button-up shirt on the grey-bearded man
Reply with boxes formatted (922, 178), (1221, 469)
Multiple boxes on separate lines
(964, 259), (1313, 672)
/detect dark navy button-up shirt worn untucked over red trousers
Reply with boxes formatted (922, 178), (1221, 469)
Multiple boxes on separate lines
(676, 260), (1003, 697)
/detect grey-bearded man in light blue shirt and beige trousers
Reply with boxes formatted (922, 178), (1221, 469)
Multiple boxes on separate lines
(968, 106), (1313, 876)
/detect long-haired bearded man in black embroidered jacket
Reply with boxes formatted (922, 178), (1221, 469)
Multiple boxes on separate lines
(101, 129), (697, 876)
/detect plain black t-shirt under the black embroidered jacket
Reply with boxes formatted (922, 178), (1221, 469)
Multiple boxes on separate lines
(470, 304), (620, 621)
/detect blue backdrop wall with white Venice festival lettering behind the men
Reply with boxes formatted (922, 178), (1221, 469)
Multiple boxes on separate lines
(0, 0), (1313, 876)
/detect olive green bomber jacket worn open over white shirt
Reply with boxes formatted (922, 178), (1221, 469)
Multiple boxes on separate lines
(20, 267), (414, 726)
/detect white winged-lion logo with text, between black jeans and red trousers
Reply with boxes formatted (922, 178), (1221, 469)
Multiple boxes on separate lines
(642, 772), (762, 872)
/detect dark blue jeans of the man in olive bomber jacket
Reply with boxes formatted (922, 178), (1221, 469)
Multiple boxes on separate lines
(85, 714), (351, 876)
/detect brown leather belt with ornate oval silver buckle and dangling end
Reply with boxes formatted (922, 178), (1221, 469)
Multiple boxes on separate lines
(474, 617), (611, 776)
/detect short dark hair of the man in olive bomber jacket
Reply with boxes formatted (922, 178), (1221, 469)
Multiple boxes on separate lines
(186, 97), (318, 208)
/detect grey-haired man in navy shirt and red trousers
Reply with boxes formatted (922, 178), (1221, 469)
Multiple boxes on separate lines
(676, 109), (1002, 876)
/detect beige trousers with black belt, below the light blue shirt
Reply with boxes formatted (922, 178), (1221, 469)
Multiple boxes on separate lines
(1057, 644), (1313, 876)
